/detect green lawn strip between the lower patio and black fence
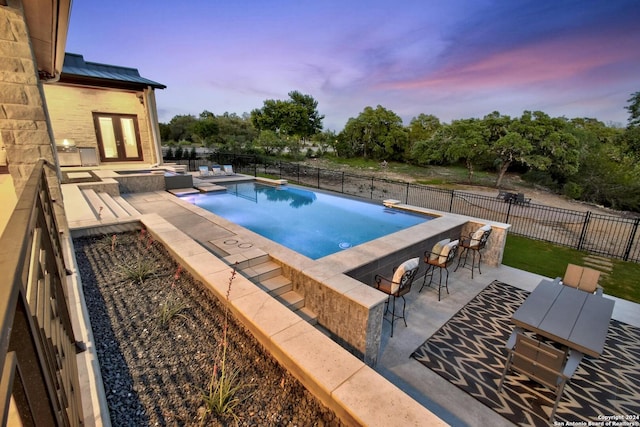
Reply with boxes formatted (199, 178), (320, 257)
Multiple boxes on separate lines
(502, 235), (640, 303)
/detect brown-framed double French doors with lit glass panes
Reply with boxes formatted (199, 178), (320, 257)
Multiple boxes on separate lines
(93, 113), (142, 162)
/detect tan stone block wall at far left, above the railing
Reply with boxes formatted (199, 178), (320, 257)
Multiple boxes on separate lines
(0, 1), (65, 227)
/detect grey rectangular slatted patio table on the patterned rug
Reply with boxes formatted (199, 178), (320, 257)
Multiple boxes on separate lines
(510, 280), (614, 360)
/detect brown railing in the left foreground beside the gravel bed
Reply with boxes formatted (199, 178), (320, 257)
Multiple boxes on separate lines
(0, 160), (83, 426)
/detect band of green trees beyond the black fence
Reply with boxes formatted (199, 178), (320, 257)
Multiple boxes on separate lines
(160, 91), (640, 212)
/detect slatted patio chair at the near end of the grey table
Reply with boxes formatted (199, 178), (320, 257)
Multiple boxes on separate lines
(498, 332), (580, 423)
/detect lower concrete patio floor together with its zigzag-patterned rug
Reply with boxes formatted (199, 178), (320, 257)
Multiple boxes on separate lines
(376, 265), (640, 426)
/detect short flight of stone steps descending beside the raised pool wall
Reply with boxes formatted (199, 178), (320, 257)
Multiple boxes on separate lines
(236, 255), (318, 325)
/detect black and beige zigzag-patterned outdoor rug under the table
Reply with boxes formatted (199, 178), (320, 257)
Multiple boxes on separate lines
(411, 281), (640, 426)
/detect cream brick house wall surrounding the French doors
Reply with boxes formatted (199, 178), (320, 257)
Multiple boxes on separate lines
(44, 83), (159, 164)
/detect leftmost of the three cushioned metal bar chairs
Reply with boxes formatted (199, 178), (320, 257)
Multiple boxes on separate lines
(374, 258), (420, 336)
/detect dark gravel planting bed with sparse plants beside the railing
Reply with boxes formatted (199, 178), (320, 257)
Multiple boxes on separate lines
(74, 231), (342, 426)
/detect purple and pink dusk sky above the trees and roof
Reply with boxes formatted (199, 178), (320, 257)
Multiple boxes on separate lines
(66, 0), (640, 131)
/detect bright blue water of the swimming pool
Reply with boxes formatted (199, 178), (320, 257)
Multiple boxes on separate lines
(184, 182), (432, 259)
